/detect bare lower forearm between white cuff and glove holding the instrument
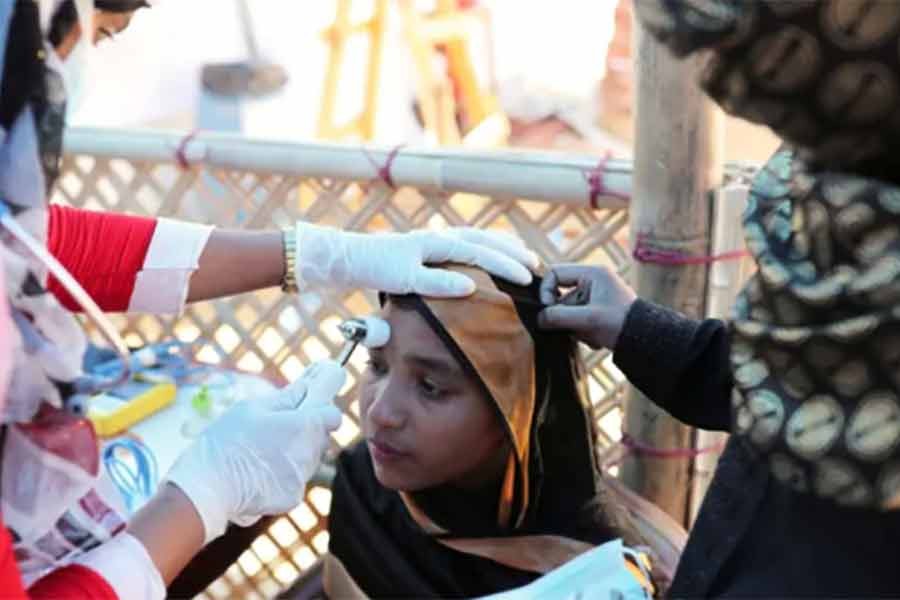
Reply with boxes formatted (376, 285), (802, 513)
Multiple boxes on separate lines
(128, 484), (204, 585)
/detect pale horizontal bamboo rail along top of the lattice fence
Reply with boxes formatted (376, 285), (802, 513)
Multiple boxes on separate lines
(63, 127), (754, 209)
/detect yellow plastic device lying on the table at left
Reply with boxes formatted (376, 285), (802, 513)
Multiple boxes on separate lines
(88, 374), (177, 438)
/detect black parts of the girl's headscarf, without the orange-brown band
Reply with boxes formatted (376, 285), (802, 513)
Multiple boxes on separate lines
(329, 274), (621, 598)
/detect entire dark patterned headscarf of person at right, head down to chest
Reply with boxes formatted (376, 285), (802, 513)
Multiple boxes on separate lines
(636, 0), (900, 510)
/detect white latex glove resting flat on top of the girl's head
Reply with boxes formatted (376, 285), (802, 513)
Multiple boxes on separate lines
(296, 222), (539, 297)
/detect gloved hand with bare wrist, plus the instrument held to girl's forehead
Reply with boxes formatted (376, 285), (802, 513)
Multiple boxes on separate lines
(113, 318), (390, 598)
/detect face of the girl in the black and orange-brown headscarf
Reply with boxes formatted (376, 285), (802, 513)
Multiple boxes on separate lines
(360, 301), (509, 492)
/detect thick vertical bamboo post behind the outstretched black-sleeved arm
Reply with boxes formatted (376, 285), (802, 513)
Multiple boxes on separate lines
(622, 12), (722, 524)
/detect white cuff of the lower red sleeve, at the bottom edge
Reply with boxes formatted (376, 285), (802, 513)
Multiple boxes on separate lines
(74, 533), (166, 600)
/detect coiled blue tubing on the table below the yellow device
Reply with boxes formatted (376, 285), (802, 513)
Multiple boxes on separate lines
(103, 438), (159, 514)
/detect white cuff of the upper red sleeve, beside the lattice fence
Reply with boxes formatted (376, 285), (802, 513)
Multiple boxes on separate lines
(128, 218), (213, 314)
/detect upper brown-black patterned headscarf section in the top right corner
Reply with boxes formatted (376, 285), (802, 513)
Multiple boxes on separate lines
(634, 0), (900, 168)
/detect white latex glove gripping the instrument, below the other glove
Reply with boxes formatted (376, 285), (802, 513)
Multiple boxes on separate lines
(168, 360), (346, 544)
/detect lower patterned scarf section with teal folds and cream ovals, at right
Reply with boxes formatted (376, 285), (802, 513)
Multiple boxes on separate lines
(731, 148), (900, 509)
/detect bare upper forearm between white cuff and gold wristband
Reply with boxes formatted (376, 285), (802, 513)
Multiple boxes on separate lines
(187, 229), (285, 302)
